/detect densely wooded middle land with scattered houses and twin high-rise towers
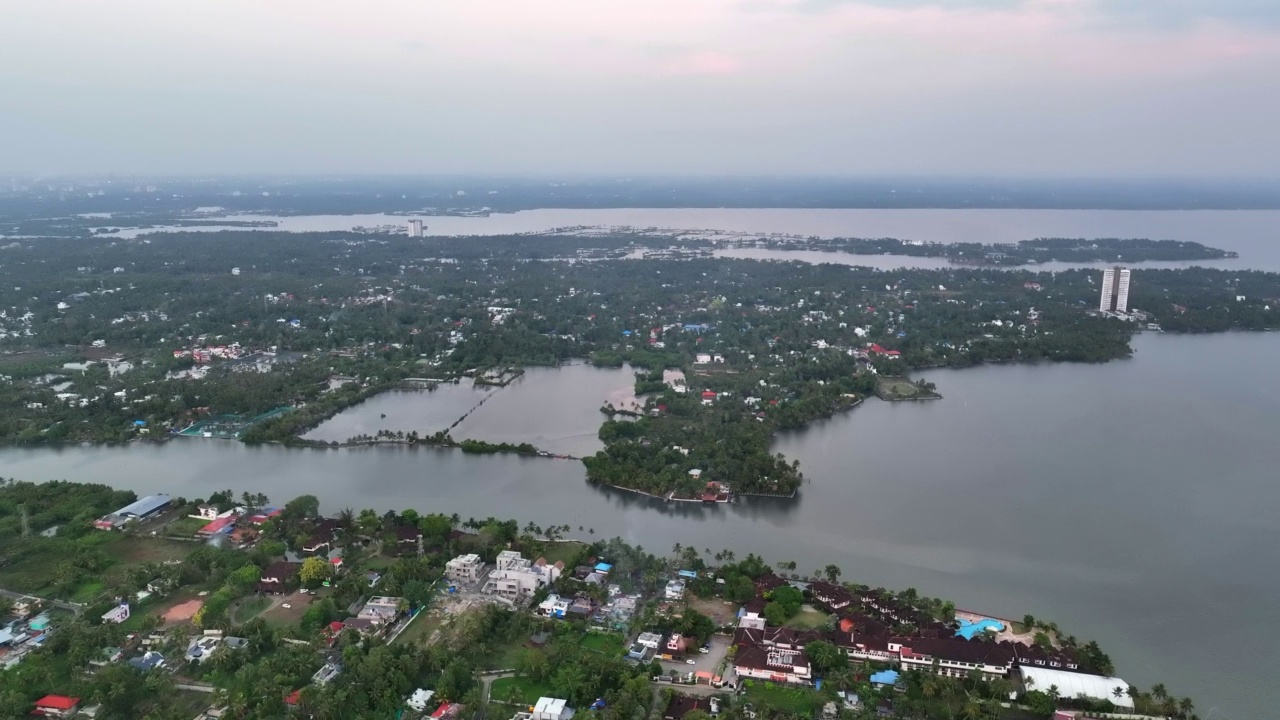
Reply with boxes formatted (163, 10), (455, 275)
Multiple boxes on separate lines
(0, 231), (1280, 501)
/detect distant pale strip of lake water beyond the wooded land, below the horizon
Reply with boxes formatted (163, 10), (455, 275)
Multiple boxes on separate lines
(107, 208), (1280, 272)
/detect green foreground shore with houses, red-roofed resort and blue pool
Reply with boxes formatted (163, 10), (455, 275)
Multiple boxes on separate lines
(0, 480), (1198, 720)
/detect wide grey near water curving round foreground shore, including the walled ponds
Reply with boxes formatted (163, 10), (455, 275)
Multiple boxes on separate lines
(0, 334), (1280, 719)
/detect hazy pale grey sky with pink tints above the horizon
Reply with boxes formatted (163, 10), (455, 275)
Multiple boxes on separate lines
(0, 0), (1280, 178)
